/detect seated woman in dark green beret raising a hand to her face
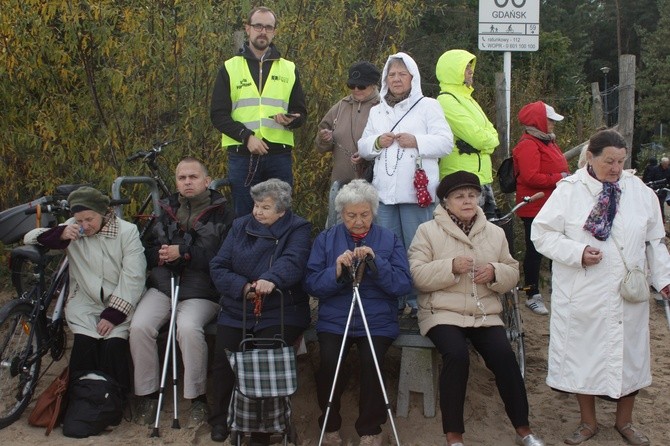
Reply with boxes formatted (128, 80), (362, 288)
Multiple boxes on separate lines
(24, 186), (147, 395)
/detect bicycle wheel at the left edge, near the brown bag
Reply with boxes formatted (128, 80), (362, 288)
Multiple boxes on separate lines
(0, 299), (41, 429)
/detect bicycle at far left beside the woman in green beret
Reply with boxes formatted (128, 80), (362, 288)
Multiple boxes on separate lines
(0, 190), (124, 429)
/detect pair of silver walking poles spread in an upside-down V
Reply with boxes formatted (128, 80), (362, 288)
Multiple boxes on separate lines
(319, 254), (400, 446)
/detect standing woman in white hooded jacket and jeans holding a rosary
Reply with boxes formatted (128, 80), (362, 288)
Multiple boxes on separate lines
(358, 53), (454, 314)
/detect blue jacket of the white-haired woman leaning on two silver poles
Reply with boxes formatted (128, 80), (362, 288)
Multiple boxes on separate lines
(305, 223), (412, 339)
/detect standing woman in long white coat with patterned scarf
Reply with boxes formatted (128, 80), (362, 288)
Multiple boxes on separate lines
(531, 130), (670, 445)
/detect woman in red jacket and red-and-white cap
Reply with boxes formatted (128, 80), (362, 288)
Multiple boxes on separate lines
(512, 101), (570, 315)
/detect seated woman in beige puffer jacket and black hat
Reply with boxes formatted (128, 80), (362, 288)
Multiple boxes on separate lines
(408, 170), (544, 446)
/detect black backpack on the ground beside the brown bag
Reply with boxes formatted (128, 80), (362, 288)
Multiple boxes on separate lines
(63, 370), (124, 438)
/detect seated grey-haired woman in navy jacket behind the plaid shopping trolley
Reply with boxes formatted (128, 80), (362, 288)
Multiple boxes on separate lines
(209, 179), (312, 445)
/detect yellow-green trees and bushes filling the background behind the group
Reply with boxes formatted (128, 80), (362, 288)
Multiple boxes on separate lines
(0, 0), (670, 230)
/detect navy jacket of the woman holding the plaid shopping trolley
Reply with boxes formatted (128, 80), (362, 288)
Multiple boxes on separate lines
(210, 211), (312, 330)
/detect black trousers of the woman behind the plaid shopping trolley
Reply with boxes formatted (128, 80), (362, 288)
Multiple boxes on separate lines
(209, 325), (305, 430)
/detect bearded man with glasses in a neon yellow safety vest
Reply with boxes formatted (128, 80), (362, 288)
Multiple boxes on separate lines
(210, 6), (307, 217)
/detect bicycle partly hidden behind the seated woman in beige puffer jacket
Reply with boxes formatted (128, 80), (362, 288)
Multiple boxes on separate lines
(489, 192), (544, 377)
